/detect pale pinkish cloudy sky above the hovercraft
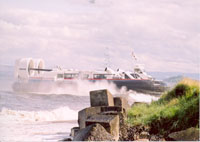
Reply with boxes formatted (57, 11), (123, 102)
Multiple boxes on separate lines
(0, 0), (200, 73)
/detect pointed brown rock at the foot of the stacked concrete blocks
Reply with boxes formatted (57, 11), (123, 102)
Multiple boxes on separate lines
(73, 123), (114, 141)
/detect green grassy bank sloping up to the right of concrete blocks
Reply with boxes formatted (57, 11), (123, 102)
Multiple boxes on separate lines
(128, 79), (200, 135)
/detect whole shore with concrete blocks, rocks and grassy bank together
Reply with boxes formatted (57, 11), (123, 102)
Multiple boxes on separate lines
(67, 79), (200, 141)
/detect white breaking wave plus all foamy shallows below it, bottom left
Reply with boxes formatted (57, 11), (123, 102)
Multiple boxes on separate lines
(0, 107), (78, 141)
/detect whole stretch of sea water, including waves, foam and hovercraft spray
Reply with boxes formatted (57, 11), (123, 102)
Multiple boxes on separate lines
(0, 67), (158, 141)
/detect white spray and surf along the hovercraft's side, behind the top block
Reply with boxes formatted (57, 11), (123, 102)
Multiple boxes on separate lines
(13, 80), (159, 104)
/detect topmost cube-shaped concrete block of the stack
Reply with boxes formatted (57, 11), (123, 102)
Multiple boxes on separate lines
(90, 89), (114, 107)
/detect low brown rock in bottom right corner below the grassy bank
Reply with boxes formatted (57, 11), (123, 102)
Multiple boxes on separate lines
(168, 127), (199, 141)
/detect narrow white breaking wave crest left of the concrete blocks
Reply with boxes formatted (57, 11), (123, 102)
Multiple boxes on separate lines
(0, 107), (78, 123)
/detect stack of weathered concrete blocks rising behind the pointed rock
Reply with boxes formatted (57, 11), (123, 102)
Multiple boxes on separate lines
(74, 89), (127, 140)
